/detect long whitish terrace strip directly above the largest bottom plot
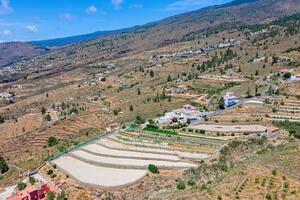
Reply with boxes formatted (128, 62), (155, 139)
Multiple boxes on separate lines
(71, 150), (197, 169)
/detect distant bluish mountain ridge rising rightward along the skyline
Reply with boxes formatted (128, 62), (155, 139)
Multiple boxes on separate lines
(29, 0), (300, 47)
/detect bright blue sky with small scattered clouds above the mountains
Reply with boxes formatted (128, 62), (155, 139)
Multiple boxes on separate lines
(0, 0), (231, 42)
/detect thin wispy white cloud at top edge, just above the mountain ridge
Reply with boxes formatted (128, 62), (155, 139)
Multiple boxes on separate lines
(165, 0), (229, 11)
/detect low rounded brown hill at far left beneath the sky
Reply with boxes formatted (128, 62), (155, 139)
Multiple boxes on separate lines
(0, 42), (47, 67)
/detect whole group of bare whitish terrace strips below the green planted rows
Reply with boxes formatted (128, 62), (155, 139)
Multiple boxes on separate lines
(52, 135), (209, 187)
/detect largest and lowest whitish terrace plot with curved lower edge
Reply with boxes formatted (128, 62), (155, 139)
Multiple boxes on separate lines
(53, 156), (147, 187)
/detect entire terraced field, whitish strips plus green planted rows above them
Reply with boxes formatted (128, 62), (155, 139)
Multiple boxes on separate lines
(52, 131), (218, 188)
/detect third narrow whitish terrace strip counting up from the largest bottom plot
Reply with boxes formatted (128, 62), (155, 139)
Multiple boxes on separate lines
(82, 144), (180, 161)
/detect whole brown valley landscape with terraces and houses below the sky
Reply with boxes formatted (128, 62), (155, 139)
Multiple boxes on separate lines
(0, 0), (300, 199)
